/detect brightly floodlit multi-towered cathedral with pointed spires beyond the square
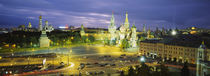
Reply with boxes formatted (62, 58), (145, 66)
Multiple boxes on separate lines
(108, 12), (138, 47)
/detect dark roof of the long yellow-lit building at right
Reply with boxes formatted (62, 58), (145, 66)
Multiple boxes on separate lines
(141, 34), (210, 48)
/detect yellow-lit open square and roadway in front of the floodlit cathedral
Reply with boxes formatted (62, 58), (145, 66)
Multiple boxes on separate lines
(0, 45), (193, 75)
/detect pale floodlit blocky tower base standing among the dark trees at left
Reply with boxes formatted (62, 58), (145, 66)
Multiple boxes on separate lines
(39, 31), (50, 47)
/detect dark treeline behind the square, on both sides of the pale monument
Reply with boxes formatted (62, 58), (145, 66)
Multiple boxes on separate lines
(0, 30), (95, 48)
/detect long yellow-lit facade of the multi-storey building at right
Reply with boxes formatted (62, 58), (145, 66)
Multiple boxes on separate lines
(139, 40), (210, 64)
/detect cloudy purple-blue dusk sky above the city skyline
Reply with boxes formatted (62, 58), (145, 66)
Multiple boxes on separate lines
(0, 0), (210, 30)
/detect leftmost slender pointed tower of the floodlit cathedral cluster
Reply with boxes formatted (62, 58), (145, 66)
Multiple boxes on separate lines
(108, 13), (116, 44)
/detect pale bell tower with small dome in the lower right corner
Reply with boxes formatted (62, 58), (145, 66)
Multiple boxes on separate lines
(196, 41), (207, 76)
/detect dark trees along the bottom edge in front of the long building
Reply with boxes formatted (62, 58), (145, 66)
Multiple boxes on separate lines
(120, 63), (190, 76)
